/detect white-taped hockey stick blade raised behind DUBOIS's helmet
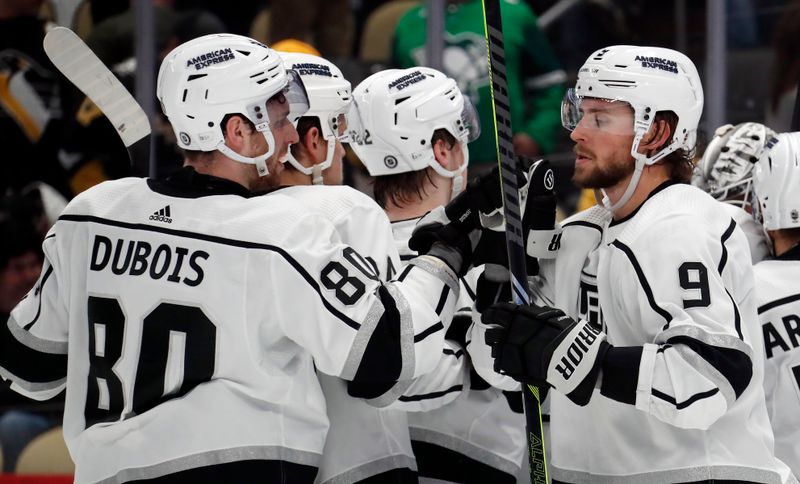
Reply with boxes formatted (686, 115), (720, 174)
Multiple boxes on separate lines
(44, 27), (150, 175)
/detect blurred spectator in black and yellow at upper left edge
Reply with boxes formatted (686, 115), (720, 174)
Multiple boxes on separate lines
(0, 0), (69, 199)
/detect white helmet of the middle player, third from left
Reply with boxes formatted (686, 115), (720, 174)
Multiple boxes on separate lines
(350, 67), (480, 197)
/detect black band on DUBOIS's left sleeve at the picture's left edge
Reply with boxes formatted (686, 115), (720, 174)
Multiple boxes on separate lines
(0, 321), (67, 383)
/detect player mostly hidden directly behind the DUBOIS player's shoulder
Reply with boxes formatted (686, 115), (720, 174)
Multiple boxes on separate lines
(280, 52), (417, 484)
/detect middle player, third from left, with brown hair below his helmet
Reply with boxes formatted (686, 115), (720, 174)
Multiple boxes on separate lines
(351, 67), (525, 483)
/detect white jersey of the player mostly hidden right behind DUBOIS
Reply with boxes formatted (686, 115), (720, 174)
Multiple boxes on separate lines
(281, 186), (416, 484)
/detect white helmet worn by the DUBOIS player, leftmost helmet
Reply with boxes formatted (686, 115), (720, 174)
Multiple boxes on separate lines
(156, 34), (308, 176)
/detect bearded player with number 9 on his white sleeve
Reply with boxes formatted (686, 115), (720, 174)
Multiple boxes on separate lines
(483, 46), (795, 483)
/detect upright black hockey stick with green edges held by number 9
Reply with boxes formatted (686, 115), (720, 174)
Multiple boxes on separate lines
(482, 0), (547, 484)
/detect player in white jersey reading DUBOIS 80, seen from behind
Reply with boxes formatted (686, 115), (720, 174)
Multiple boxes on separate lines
(0, 35), (488, 483)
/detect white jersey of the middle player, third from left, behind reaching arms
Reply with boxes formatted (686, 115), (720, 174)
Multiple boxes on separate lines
(392, 219), (526, 481)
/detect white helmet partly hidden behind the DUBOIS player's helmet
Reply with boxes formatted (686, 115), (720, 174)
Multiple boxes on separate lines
(280, 52), (351, 185)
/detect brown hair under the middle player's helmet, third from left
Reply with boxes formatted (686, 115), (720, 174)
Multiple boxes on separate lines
(370, 129), (456, 209)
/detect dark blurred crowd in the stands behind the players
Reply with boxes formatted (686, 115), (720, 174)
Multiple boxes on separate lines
(0, 0), (800, 472)
